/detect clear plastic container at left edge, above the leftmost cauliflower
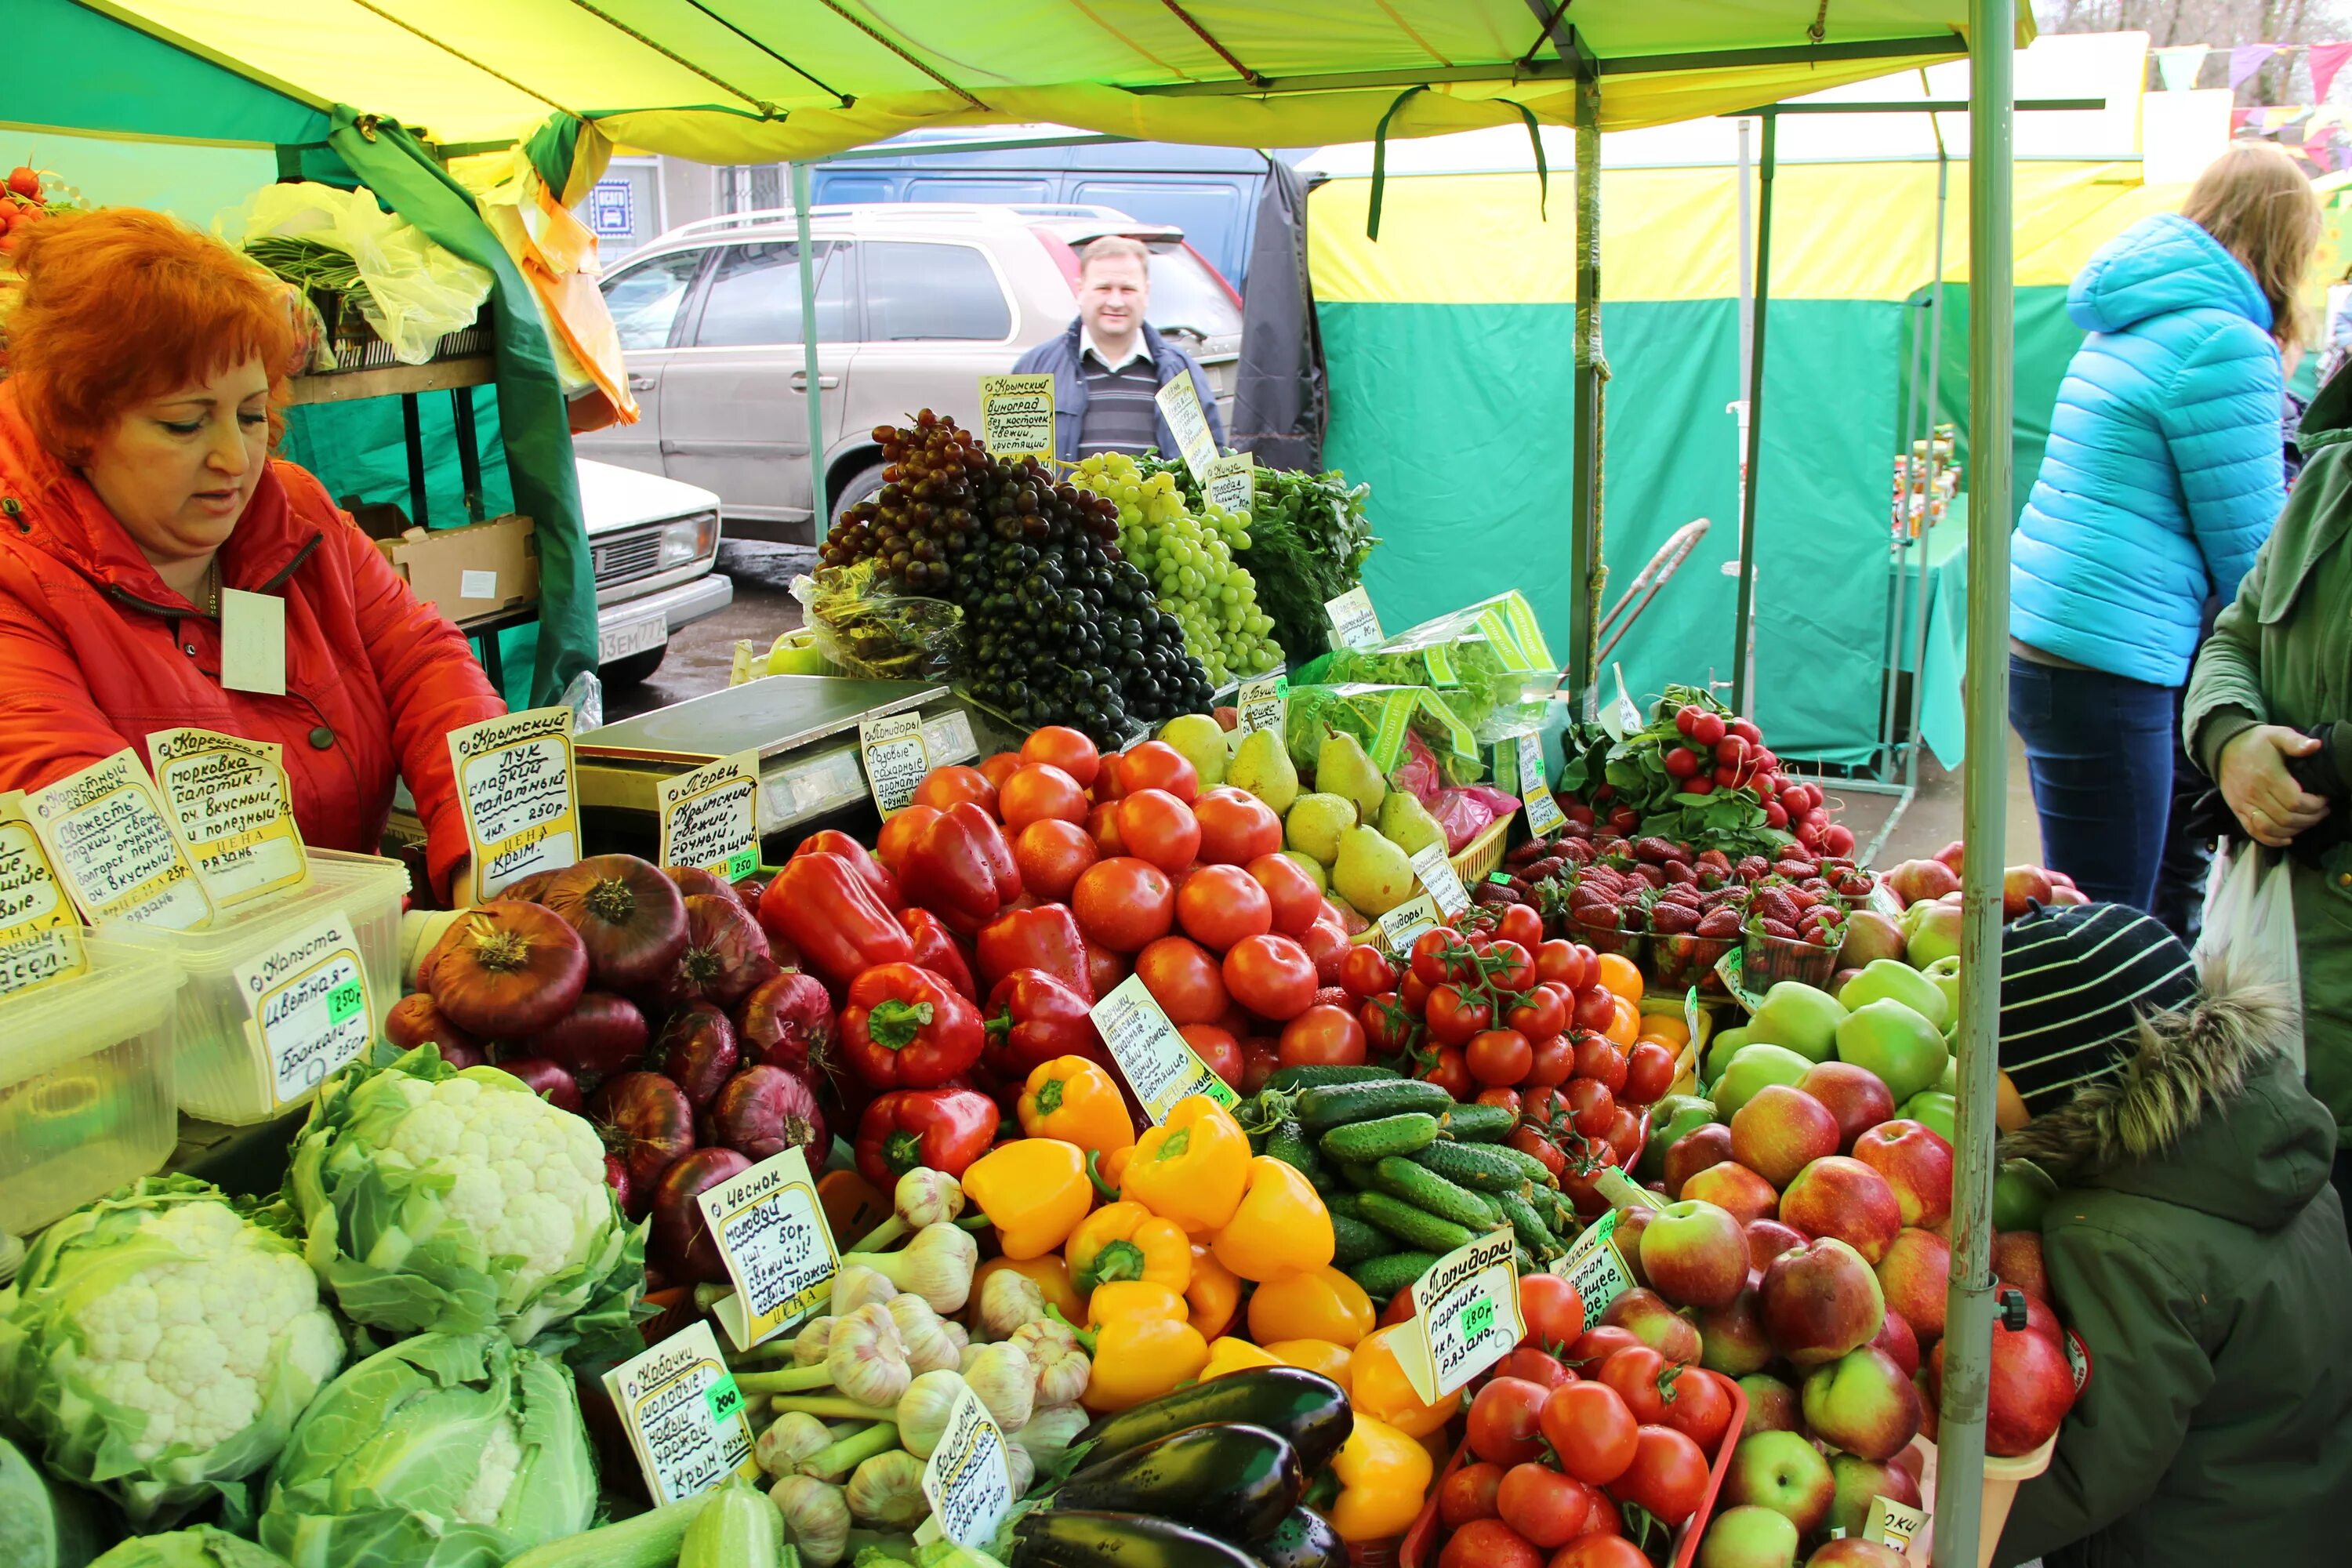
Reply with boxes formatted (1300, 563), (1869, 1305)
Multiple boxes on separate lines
(0, 938), (181, 1236)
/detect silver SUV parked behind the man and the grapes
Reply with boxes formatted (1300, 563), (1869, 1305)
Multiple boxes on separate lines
(576, 202), (1242, 543)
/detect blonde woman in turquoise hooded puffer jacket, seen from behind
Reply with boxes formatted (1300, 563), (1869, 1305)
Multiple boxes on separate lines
(2009, 143), (2319, 909)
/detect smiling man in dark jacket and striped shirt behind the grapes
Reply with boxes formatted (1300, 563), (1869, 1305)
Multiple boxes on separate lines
(1014, 235), (1225, 463)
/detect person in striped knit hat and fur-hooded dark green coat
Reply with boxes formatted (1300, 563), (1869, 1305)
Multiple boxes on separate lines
(1992, 905), (2352, 1568)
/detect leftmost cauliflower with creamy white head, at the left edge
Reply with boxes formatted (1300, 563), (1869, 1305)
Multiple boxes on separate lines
(0, 1175), (343, 1523)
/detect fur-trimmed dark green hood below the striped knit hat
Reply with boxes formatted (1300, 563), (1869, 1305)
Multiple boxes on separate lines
(2002, 959), (2336, 1229)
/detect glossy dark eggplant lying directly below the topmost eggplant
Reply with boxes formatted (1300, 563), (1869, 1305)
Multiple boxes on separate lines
(1054, 1425), (1308, 1547)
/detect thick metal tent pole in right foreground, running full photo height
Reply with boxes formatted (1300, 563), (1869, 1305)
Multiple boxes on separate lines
(1936, 0), (2018, 1568)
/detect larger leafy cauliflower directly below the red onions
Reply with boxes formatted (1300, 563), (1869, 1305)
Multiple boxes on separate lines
(287, 1046), (644, 1349)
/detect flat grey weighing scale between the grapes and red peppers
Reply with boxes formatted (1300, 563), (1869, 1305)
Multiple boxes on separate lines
(574, 675), (1011, 865)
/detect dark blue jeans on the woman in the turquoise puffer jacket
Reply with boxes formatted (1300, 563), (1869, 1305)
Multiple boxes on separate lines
(2009, 654), (2180, 909)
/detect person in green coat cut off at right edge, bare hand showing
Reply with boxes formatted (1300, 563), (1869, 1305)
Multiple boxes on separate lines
(2180, 361), (2352, 1208)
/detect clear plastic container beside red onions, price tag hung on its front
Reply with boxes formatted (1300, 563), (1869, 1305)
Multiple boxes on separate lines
(103, 848), (409, 1126)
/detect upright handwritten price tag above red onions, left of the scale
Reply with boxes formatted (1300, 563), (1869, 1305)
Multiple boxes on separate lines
(449, 708), (581, 898)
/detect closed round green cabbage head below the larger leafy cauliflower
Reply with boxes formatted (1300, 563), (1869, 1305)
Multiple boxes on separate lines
(261, 1333), (595, 1568)
